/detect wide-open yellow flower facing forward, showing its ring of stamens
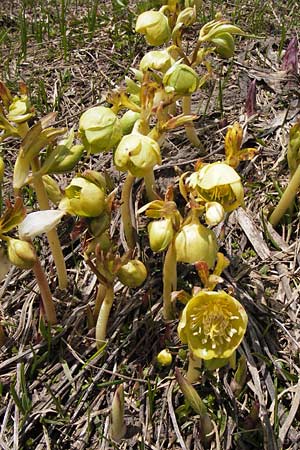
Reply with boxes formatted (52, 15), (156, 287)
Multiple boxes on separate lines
(178, 291), (248, 360)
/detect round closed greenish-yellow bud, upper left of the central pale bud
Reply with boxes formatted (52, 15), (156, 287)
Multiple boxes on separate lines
(79, 106), (122, 153)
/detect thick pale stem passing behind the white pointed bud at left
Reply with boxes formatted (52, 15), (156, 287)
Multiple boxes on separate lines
(32, 160), (68, 289)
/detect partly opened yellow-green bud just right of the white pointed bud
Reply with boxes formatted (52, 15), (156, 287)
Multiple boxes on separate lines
(59, 176), (105, 217)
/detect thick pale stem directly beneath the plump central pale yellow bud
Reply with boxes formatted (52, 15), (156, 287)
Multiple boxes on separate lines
(121, 173), (136, 249)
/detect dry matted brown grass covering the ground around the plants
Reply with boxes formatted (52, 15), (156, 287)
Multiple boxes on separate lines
(0, 1), (300, 450)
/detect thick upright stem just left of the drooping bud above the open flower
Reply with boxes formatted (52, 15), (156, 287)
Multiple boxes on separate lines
(163, 241), (177, 320)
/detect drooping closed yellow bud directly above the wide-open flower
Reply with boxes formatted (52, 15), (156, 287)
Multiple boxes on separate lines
(175, 215), (218, 268)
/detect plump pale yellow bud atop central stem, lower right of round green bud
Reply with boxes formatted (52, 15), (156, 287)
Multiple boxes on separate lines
(114, 134), (161, 177)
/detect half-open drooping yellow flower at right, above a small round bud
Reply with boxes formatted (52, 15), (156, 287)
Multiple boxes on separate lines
(187, 162), (244, 212)
